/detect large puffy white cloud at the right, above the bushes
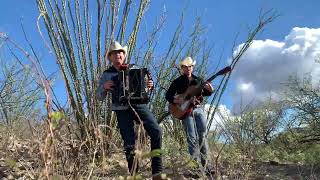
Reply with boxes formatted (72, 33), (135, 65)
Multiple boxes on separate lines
(232, 27), (320, 112)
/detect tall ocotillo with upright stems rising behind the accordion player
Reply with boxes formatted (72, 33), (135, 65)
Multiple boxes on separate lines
(37, 0), (149, 139)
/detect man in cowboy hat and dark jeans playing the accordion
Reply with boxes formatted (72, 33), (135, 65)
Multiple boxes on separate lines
(96, 41), (162, 179)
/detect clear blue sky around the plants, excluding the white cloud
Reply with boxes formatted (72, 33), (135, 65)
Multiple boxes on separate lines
(0, 0), (320, 112)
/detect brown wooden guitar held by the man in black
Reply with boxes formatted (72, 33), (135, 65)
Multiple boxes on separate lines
(169, 66), (231, 120)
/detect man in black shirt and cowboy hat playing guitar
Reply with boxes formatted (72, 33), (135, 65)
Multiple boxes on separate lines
(166, 57), (213, 176)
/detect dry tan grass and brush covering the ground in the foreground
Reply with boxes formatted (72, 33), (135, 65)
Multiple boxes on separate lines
(0, 122), (320, 179)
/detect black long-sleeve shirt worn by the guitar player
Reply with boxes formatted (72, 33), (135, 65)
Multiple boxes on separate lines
(166, 74), (213, 103)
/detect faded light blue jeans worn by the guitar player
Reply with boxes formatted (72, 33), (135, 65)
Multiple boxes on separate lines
(182, 107), (208, 167)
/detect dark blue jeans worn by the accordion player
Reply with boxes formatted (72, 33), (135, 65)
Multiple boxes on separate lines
(115, 104), (162, 174)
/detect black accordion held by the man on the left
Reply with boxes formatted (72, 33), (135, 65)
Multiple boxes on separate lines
(112, 65), (150, 104)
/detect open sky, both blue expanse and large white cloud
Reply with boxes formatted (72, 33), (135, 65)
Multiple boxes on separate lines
(0, 0), (320, 116)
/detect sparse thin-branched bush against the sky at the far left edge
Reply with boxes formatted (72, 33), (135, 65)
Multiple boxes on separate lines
(0, 58), (44, 127)
